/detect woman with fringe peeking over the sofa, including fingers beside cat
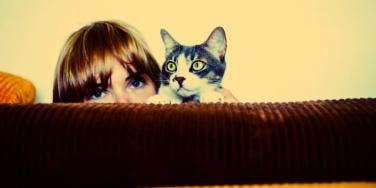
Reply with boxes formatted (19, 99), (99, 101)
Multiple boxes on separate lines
(53, 21), (237, 103)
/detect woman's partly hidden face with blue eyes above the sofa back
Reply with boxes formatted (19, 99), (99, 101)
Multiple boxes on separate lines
(85, 61), (156, 103)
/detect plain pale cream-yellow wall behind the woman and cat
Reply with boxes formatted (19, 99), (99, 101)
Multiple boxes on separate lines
(0, 0), (376, 102)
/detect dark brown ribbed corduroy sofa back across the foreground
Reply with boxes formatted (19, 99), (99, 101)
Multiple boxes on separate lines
(0, 99), (376, 187)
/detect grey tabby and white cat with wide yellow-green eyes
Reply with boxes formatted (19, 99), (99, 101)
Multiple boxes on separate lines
(147, 27), (227, 104)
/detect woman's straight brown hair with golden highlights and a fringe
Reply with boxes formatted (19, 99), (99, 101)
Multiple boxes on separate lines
(53, 21), (160, 102)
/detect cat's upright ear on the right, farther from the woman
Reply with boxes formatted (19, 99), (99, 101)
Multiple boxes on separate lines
(204, 27), (227, 58)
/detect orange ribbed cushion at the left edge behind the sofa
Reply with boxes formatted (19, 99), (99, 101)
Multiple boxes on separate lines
(0, 71), (35, 104)
